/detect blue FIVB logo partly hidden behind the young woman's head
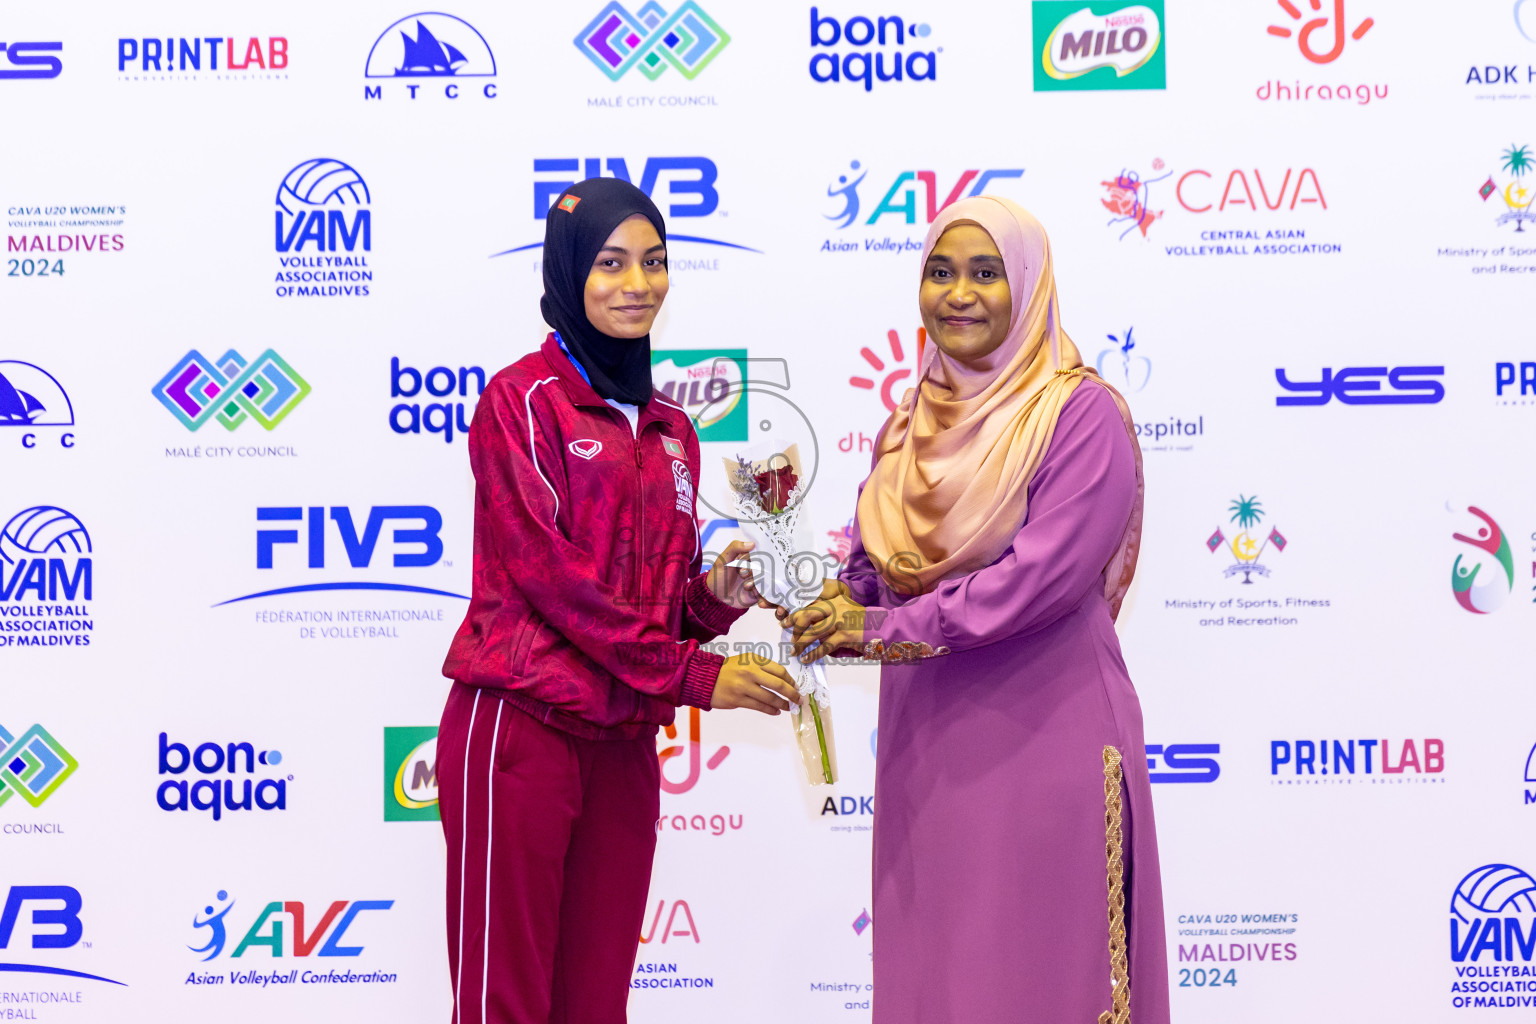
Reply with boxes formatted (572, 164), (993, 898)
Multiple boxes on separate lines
(492, 157), (762, 260)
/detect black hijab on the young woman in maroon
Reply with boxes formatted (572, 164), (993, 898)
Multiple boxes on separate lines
(539, 178), (667, 405)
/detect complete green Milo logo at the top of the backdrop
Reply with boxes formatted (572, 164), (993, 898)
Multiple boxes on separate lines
(1034, 0), (1167, 92)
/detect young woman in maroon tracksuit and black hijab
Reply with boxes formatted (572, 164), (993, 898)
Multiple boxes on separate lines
(438, 178), (799, 1024)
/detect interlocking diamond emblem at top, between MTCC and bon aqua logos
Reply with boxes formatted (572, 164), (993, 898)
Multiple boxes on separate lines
(574, 0), (731, 81)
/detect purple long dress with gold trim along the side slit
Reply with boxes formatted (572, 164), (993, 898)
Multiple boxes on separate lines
(842, 382), (1169, 1024)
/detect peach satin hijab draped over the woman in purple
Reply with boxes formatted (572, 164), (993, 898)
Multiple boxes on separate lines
(859, 195), (1144, 614)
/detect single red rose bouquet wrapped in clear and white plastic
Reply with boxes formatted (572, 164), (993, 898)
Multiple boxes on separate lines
(725, 444), (837, 786)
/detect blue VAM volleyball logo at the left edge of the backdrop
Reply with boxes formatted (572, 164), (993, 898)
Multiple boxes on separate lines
(0, 505), (95, 646)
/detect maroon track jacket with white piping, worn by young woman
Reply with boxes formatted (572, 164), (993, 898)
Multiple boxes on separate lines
(442, 335), (742, 738)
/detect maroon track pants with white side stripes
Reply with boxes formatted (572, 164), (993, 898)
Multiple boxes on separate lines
(438, 683), (660, 1024)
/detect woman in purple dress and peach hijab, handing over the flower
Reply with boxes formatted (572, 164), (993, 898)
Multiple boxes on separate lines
(791, 197), (1169, 1024)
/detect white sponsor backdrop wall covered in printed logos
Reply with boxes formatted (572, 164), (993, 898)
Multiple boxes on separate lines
(0, 0), (1536, 1022)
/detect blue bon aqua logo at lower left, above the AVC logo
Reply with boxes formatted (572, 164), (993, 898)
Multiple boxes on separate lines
(155, 732), (293, 821)
